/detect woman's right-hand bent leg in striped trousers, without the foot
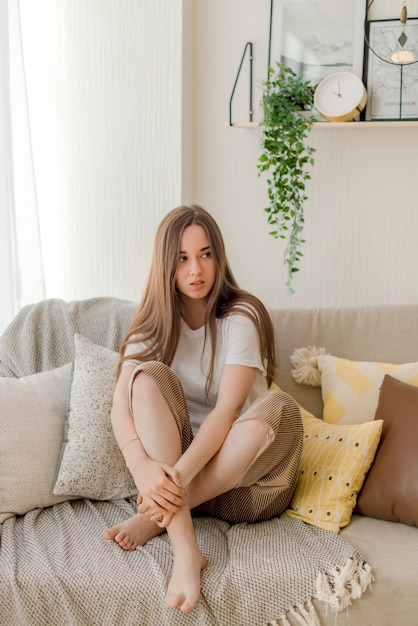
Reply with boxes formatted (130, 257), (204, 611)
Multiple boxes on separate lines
(189, 391), (303, 524)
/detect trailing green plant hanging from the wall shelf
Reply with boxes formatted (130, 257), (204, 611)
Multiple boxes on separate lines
(257, 63), (315, 293)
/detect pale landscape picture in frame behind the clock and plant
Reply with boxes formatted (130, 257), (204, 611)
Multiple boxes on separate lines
(268, 0), (366, 86)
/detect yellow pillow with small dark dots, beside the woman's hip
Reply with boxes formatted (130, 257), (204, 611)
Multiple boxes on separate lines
(286, 408), (383, 533)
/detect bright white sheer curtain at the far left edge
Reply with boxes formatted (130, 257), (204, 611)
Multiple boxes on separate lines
(0, 0), (45, 331)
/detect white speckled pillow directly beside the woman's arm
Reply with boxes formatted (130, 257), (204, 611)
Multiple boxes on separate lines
(54, 334), (137, 500)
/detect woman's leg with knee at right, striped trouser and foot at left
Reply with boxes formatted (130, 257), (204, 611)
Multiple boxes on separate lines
(105, 391), (303, 550)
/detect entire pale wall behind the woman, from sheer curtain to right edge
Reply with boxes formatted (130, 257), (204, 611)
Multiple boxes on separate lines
(6, 0), (418, 332)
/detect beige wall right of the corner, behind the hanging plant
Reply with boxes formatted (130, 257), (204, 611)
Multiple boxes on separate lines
(193, 0), (418, 306)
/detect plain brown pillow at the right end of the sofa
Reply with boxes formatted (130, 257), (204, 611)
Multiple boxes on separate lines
(356, 374), (418, 526)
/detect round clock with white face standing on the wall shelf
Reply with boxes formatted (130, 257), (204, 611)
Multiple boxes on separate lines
(314, 72), (367, 122)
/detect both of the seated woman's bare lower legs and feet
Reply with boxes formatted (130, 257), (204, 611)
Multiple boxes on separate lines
(103, 374), (301, 612)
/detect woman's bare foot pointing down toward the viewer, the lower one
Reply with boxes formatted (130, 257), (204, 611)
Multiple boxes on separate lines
(164, 546), (207, 613)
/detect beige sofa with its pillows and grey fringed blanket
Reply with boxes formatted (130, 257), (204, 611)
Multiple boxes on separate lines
(0, 298), (418, 626)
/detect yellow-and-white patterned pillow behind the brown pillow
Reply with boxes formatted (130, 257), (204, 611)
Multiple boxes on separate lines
(317, 355), (418, 424)
